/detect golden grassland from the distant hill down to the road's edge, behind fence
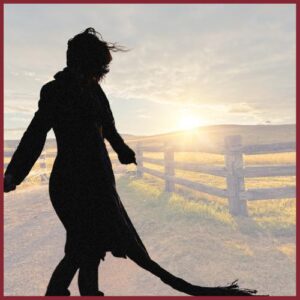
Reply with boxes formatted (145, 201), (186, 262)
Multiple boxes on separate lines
(4, 124), (296, 236)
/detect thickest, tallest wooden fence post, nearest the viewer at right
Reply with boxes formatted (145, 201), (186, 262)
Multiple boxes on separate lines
(224, 135), (248, 216)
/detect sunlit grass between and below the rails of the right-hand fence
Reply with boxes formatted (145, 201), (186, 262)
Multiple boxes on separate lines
(122, 153), (296, 236)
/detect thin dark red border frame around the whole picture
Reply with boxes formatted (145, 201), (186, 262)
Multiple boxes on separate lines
(0, 0), (300, 300)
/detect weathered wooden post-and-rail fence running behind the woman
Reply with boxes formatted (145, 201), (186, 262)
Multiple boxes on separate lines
(4, 135), (296, 216)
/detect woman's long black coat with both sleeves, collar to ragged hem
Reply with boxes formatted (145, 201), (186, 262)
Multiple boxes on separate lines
(5, 68), (148, 259)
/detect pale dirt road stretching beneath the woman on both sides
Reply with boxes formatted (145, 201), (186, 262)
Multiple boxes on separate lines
(4, 179), (295, 296)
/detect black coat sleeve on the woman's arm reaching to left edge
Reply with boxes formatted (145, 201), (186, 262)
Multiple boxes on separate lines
(5, 84), (54, 185)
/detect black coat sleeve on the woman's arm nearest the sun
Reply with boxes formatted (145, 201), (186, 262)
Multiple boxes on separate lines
(99, 86), (128, 154)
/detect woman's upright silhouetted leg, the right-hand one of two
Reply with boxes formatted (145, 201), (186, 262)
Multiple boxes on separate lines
(78, 257), (103, 296)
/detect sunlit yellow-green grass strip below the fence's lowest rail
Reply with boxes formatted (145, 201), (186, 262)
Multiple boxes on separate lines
(124, 175), (296, 236)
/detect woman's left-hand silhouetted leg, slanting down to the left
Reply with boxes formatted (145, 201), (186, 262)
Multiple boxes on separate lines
(45, 254), (79, 296)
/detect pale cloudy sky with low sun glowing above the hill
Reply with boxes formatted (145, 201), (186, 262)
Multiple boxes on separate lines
(4, 4), (296, 139)
